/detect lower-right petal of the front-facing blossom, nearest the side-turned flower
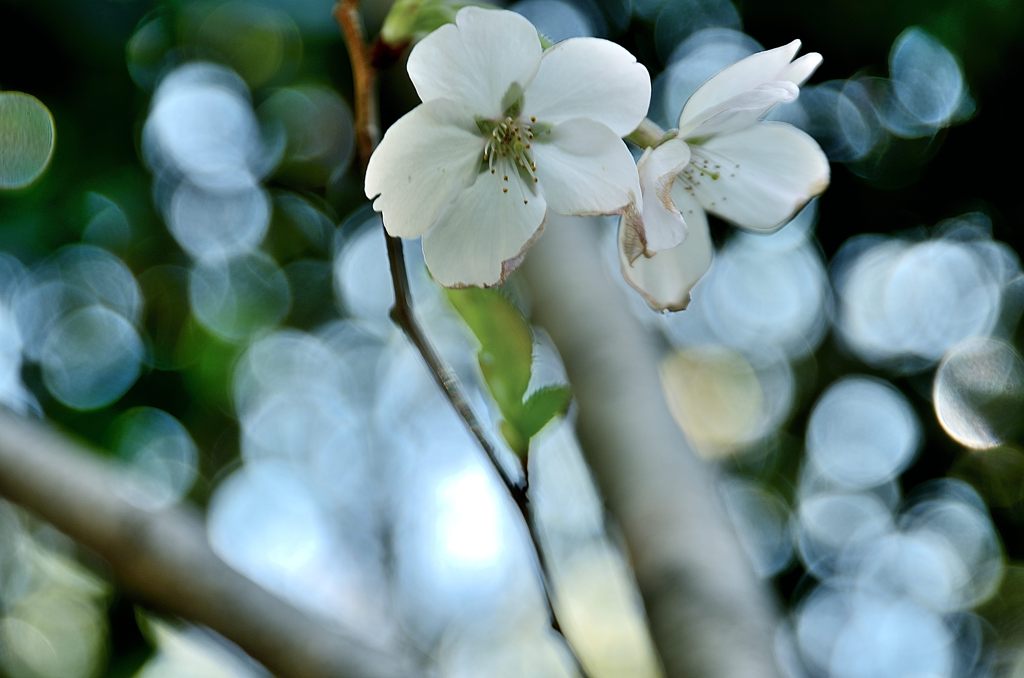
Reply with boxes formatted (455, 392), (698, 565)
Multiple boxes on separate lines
(532, 120), (640, 215)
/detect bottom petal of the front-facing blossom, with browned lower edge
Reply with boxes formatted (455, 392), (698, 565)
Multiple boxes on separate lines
(423, 172), (547, 287)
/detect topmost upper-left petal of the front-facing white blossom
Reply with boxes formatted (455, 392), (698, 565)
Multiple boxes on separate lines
(409, 7), (542, 118)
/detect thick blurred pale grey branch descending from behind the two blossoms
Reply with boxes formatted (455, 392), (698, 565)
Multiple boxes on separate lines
(524, 219), (777, 678)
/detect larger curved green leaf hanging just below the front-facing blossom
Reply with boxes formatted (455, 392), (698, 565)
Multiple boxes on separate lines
(447, 287), (534, 413)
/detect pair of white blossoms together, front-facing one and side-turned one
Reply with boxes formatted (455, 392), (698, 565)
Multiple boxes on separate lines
(365, 7), (828, 310)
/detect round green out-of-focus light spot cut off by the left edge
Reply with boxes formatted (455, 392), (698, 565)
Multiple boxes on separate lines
(0, 92), (55, 189)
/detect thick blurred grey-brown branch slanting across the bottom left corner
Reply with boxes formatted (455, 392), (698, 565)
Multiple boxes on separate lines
(0, 411), (417, 678)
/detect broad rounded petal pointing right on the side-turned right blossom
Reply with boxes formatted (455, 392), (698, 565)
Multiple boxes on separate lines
(683, 122), (828, 231)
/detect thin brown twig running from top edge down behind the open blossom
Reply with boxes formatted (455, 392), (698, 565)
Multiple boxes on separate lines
(334, 0), (587, 678)
